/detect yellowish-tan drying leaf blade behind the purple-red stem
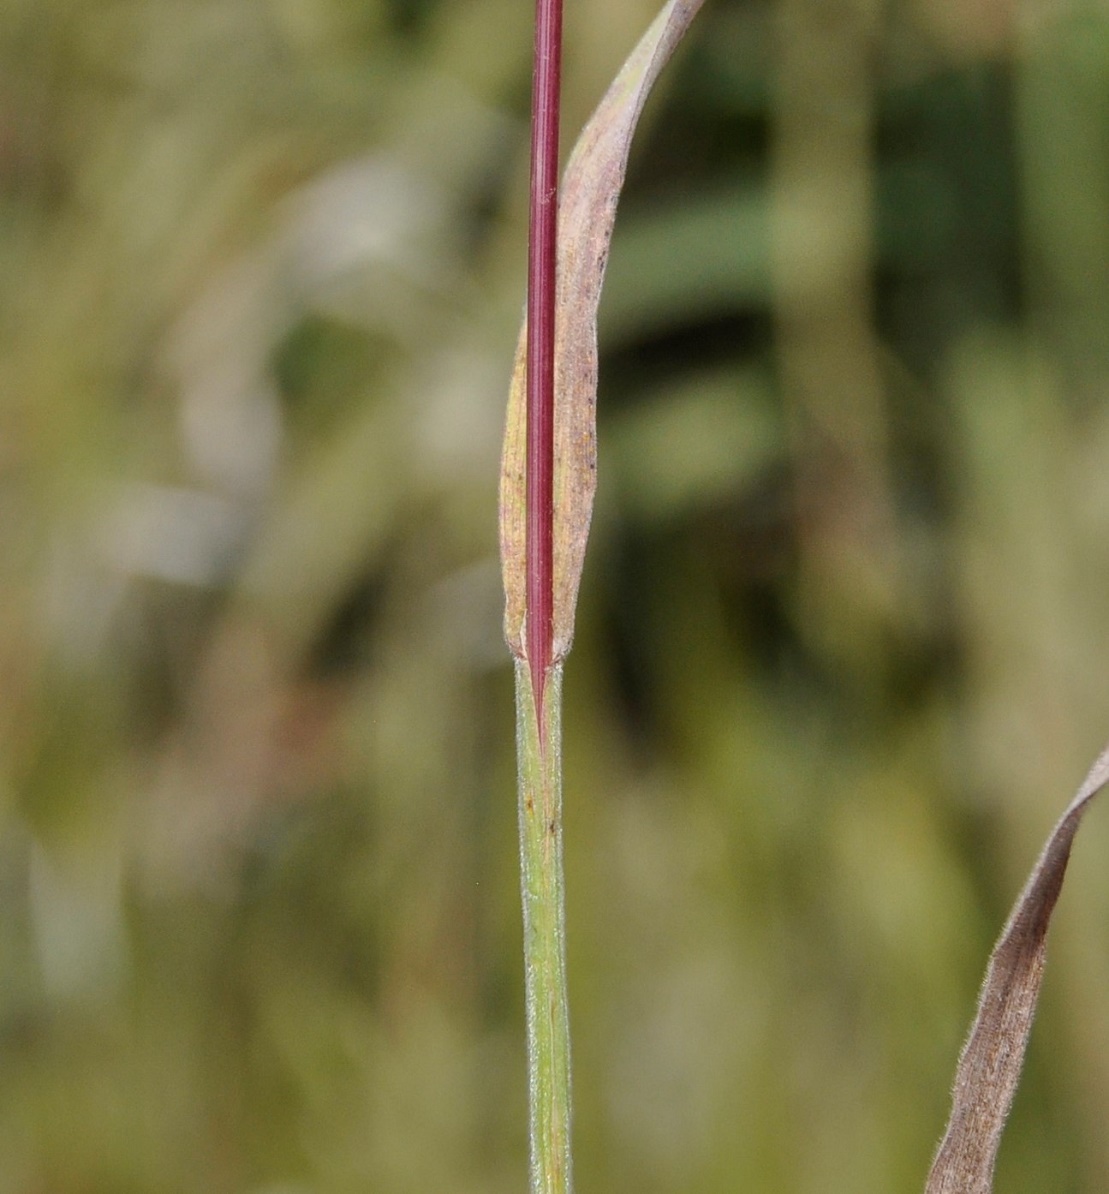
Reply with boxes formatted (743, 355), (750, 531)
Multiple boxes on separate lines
(500, 0), (703, 663)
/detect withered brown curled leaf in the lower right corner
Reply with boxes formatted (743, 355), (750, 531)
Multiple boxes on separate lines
(925, 749), (1109, 1194)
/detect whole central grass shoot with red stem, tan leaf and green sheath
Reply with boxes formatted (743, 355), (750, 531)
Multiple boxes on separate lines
(500, 0), (701, 1194)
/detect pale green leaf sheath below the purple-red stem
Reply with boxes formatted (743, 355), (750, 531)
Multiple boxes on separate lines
(516, 659), (573, 1194)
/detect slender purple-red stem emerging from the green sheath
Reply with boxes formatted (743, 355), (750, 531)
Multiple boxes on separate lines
(525, 0), (562, 733)
